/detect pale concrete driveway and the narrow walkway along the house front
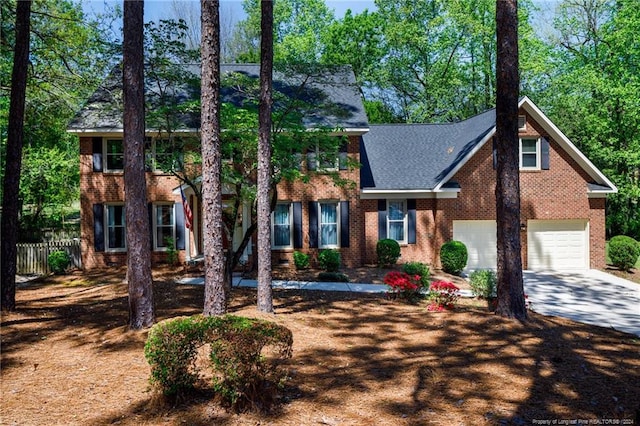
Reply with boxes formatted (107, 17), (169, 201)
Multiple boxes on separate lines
(178, 270), (640, 336)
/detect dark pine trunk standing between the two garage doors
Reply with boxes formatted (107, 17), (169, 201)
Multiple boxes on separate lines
(496, 0), (527, 320)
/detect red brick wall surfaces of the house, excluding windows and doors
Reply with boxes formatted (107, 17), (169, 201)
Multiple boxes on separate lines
(80, 105), (605, 268)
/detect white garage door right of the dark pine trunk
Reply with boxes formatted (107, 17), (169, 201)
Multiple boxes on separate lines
(527, 220), (589, 270)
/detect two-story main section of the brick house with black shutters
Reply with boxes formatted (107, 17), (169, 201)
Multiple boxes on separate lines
(68, 64), (369, 268)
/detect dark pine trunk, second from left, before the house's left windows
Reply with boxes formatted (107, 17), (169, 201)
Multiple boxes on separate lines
(122, 0), (154, 330)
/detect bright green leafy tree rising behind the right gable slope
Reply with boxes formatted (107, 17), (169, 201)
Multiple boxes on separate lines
(540, 0), (640, 239)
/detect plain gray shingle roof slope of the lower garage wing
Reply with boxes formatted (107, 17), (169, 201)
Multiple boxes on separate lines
(360, 109), (496, 191)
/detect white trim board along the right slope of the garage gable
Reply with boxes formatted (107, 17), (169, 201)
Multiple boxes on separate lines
(518, 96), (618, 194)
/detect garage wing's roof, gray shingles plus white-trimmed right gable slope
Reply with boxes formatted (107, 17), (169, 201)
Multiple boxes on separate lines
(361, 97), (617, 194)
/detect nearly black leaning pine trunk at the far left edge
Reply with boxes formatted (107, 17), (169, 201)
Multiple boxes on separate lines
(0, 0), (31, 311)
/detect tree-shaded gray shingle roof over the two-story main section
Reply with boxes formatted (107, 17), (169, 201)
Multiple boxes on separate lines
(68, 64), (369, 132)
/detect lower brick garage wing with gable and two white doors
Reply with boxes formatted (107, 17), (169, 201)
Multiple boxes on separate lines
(360, 97), (617, 270)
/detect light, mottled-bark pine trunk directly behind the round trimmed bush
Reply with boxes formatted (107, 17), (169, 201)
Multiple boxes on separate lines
(201, 0), (231, 316)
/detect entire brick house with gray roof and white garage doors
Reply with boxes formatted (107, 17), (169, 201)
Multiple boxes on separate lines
(69, 65), (617, 269)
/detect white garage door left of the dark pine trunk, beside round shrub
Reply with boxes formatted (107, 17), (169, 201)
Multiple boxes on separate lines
(453, 220), (498, 270)
